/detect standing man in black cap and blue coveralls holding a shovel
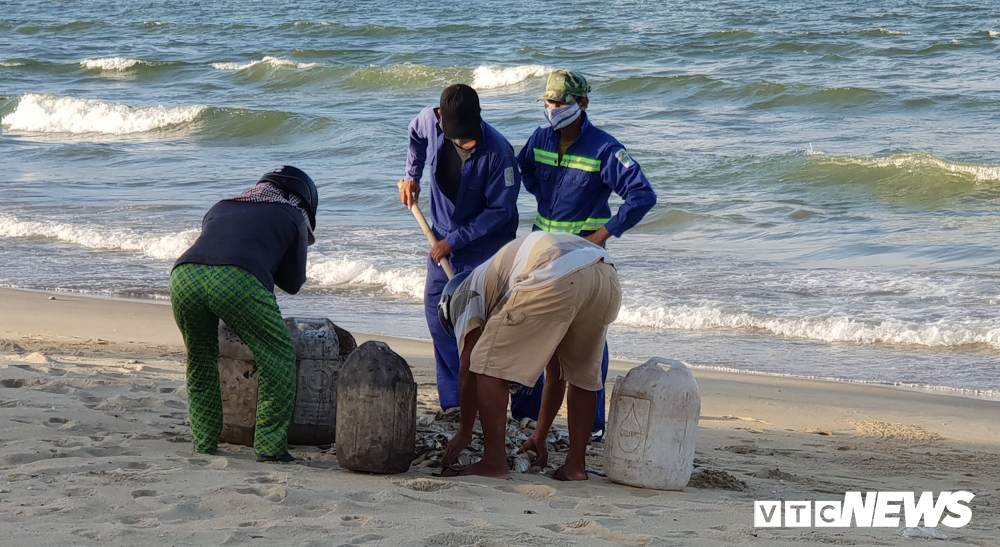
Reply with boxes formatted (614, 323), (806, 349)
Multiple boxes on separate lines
(399, 84), (521, 410)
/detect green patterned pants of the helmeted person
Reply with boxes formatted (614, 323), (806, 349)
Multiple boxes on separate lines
(170, 264), (296, 456)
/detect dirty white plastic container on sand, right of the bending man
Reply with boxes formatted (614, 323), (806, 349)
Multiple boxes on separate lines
(604, 357), (701, 490)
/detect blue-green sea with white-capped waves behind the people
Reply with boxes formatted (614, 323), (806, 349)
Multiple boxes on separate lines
(0, 0), (1000, 395)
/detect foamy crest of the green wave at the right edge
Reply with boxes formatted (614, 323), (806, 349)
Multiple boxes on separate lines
(806, 149), (1000, 183)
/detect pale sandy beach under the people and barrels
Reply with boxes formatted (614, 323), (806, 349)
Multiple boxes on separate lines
(0, 290), (1000, 547)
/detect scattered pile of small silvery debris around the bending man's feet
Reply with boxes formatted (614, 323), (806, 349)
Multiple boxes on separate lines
(413, 408), (602, 474)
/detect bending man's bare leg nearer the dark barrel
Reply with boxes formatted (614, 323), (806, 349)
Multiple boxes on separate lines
(458, 372), (512, 480)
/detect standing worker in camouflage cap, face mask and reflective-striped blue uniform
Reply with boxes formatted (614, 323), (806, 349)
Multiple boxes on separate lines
(517, 70), (656, 435)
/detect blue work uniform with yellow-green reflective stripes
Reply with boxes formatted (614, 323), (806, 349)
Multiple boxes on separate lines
(515, 114), (656, 433)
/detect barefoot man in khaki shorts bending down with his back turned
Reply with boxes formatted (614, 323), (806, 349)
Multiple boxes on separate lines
(439, 232), (621, 480)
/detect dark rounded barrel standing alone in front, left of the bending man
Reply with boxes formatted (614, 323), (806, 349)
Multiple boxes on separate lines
(337, 342), (417, 473)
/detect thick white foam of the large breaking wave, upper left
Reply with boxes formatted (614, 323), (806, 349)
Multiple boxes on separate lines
(0, 93), (208, 135)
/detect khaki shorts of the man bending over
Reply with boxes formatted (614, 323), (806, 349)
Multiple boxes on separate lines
(469, 262), (622, 391)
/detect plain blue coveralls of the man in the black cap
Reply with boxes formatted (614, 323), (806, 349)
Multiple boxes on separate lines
(404, 107), (521, 410)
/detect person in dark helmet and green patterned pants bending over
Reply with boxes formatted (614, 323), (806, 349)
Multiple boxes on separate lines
(170, 166), (319, 462)
